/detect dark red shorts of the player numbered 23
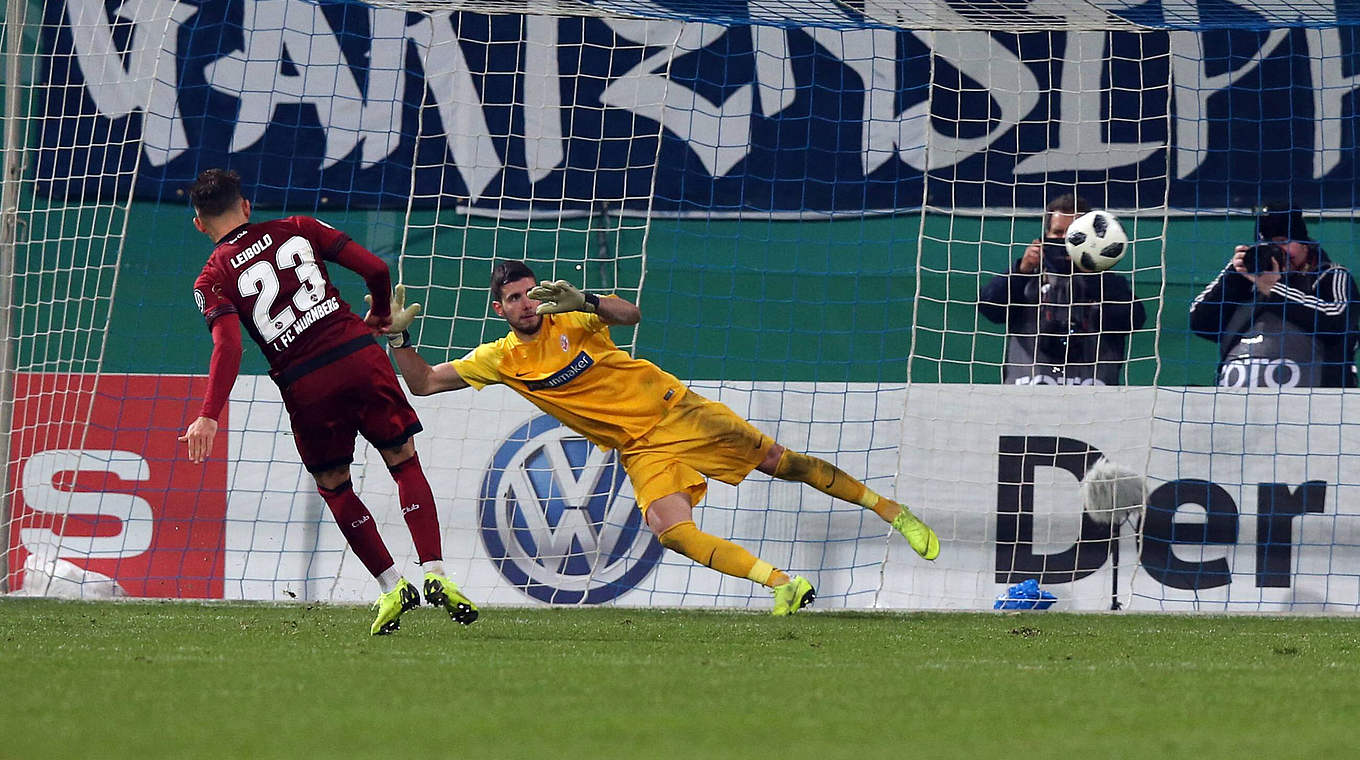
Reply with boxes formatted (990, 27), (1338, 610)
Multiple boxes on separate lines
(282, 343), (422, 472)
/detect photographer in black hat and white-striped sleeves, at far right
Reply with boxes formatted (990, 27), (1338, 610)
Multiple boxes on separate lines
(1190, 204), (1360, 387)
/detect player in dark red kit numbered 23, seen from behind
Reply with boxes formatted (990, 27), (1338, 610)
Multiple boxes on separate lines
(180, 169), (477, 635)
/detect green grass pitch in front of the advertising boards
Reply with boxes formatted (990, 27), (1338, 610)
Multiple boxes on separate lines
(0, 598), (1360, 760)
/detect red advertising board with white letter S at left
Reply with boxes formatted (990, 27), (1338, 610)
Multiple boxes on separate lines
(7, 374), (227, 598)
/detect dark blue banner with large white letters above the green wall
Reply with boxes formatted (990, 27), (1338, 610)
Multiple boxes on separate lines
(33, 0), (1360, 215)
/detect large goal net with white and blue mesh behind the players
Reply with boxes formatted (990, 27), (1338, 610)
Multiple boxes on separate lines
(0, 0), (1360, 610)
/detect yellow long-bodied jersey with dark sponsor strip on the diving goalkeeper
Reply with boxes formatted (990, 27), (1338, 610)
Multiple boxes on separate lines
(452, 304), (685, 449)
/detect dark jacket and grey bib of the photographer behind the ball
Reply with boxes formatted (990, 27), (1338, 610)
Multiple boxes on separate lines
(978, 243), (1148, 385)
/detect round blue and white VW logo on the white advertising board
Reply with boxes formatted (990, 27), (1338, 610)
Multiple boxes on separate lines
(477, 415), (662, 604)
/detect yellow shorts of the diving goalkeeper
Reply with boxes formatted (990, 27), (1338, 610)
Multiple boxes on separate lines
(619, 390), (774, 513)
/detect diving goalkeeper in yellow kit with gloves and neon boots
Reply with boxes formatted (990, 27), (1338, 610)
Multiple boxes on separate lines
(388, 261), (940, 615)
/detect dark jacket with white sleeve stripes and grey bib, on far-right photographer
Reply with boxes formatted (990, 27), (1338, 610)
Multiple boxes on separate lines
(1190, 246), (1360, 387)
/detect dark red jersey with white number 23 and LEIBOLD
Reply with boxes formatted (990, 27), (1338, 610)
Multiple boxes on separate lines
(193, 216), (373, 379)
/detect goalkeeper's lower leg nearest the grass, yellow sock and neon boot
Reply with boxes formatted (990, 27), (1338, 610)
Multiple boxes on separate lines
(645, 492), (817, 616)
